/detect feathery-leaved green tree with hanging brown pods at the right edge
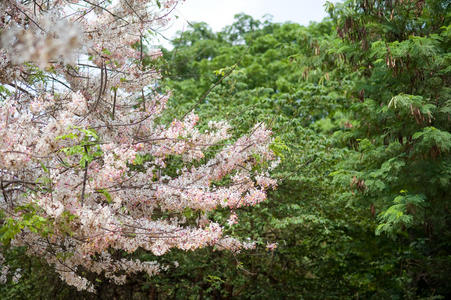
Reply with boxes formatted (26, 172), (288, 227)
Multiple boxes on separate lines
(329, 0), (451, 298)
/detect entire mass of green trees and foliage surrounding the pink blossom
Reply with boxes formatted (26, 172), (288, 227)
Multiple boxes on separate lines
(0, 0), (451, 299)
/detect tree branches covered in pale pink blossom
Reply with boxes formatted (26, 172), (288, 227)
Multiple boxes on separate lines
(0, 0), (276, 291)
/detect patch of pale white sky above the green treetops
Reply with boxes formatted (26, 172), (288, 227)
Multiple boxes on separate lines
(157, 0), (337, 47)
